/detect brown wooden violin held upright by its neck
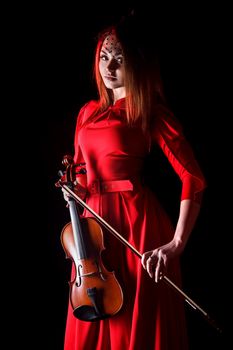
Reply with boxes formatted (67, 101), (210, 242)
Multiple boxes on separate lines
(59, 156), (123, 321)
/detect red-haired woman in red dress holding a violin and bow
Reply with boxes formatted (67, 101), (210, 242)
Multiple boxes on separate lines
(64, 15), (206, 350)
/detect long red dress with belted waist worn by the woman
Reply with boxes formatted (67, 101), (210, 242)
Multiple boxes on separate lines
(64, 99), (205, 350)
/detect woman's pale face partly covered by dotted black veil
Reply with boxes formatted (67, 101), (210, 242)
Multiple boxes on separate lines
(99, 34), (124, 90)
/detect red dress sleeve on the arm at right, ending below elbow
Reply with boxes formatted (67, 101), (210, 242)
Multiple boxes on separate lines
(152, 105), (206, 202)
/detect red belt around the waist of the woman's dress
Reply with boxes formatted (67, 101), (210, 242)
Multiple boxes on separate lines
(87, 180), (134, 194)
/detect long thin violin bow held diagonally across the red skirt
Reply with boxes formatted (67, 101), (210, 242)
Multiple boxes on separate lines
(58, 180), (222, 333)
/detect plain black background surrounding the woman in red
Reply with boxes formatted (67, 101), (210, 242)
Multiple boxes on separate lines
(5, 2), (229, 350)
